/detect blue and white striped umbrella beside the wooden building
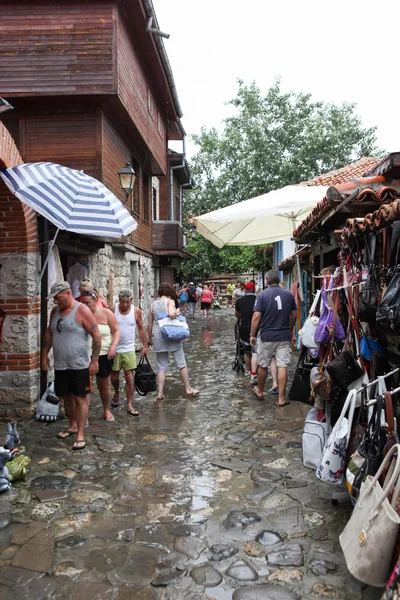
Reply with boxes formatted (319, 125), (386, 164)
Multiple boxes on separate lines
(0, 162), (137, 238)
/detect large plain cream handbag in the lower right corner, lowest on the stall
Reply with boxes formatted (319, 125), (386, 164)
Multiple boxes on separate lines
(339, 444), (400, 587)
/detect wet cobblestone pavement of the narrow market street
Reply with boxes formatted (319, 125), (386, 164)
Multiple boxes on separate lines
(0, 310), (382, 600)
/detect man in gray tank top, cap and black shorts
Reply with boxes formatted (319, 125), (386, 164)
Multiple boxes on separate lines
(41, 281), (101, 450)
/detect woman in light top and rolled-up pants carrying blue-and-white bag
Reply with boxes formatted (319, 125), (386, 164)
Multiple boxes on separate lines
(148, 283), (200, 401)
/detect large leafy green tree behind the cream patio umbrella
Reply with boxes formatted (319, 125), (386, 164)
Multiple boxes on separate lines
(184, 80), (381, 277)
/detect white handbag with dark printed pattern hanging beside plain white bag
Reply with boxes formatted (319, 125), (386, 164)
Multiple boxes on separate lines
(316, 390), (357, 485)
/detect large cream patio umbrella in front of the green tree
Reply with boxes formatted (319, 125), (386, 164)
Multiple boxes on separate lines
(194, 185), (328, 299)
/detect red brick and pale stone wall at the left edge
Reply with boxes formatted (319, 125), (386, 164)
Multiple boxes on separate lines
(0, 121), (40, 420)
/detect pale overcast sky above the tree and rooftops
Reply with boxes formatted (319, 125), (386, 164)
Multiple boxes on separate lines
(153, 0), (400, 161)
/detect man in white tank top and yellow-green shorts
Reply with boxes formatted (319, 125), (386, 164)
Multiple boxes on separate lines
(111, 290), (148, 417)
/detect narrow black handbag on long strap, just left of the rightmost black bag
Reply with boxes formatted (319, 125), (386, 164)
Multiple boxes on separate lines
(358, 233), (381, 323)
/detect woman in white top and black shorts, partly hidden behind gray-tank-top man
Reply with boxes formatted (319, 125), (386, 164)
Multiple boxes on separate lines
(81, 290), (119, 421)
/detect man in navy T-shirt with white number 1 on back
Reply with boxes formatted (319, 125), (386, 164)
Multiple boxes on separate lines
(250, 271), (297, 406)
